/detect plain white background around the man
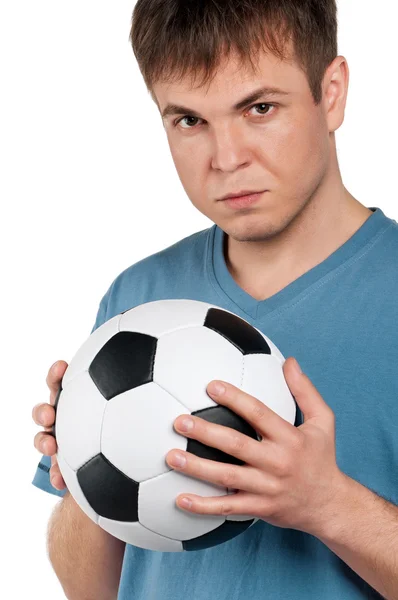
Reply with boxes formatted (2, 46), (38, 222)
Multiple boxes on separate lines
(0, 0), (398, 600)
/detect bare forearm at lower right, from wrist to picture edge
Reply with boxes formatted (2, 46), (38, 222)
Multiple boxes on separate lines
(316, 475), (398, 600)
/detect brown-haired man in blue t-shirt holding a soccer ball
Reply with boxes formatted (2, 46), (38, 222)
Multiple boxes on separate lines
(33, 0), (398, 600)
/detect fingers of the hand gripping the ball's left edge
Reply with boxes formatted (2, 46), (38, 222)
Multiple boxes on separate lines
(32, 360), (68, 490)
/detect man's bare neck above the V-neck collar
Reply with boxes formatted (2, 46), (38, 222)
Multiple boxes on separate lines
(224, 183), (372, 300)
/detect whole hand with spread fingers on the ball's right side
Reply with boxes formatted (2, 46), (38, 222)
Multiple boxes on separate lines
(166, 357), (346, 535)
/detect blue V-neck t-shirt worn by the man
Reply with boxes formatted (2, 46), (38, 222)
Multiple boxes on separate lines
(33, 208), (398, 600)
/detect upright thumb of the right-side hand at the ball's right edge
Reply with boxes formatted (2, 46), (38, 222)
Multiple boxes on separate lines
(283, 356), (333, 423)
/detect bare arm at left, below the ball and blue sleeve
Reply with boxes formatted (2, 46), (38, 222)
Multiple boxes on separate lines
(47, 493), (125, 600)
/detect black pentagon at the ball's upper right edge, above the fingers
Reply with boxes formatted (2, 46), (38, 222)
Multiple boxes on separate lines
(204, 308), (271, 355)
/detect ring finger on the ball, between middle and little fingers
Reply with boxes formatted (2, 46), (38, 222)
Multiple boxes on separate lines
(166, 450), (265, 494)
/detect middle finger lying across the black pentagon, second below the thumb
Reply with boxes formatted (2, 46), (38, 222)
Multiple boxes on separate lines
(174, 415), (274, 469)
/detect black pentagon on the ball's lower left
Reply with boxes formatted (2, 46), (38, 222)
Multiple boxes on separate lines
(76, 453), (139, 522)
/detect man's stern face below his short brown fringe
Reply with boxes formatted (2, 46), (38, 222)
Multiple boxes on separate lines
(153, 43), (344, 241)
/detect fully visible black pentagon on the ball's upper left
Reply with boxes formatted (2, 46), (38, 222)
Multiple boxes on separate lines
(88, 331), (158, 400)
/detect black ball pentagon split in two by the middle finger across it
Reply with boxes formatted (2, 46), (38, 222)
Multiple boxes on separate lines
(187, 405), (258, 465)
